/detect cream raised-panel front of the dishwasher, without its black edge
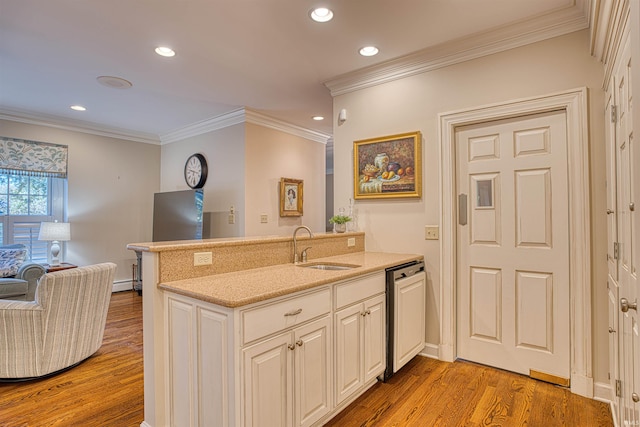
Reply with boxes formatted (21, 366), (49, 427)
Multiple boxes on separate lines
(393, 273), (426, 372)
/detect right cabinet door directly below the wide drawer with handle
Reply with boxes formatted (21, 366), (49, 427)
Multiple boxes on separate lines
(296, 316), (332, 426)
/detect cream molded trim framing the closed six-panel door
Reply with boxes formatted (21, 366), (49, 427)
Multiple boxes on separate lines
(438, 88), (593, 397)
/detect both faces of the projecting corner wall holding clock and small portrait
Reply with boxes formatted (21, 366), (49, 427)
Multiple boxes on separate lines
(160, 123), (325, 237)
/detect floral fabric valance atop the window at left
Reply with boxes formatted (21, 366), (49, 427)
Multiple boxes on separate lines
(0, 136), (68, 178)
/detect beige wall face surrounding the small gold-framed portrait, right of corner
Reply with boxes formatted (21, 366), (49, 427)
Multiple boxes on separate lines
(245, 123), (326, 236)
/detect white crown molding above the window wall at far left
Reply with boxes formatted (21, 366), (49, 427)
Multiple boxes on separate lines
(0, 108), (160, 145)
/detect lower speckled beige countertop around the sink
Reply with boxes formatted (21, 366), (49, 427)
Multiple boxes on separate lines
(158, 252), (423, 308)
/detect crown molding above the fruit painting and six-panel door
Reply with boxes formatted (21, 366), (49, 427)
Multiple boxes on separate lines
(324, 0), (591, 97)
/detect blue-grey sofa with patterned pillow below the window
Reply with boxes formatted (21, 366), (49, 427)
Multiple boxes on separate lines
(0, 244), (45, 301)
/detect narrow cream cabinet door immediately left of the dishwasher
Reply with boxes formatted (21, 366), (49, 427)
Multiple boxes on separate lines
(363, 295), (386, 382)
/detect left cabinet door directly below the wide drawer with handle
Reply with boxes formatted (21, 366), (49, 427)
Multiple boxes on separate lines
(243, 333), (293, 427)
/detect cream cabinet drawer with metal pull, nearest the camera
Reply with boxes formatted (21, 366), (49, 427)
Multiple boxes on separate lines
(242, 288), (331, 344)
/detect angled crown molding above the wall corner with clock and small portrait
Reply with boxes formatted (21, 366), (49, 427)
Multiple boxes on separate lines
(160, 108), (331, 144)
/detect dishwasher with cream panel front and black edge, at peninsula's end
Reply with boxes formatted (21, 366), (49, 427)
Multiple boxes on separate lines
(380, 261), (426, 381)
